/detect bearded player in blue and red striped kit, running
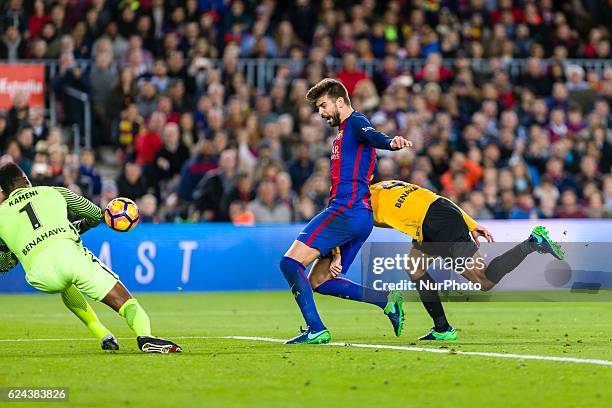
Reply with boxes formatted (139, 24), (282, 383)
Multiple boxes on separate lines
(280, 78), (411, 344)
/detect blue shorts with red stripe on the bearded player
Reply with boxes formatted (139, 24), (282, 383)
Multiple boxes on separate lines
(297, 206), (374, 273)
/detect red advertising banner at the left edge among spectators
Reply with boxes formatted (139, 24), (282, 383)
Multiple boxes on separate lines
(0, 64), (45, 110)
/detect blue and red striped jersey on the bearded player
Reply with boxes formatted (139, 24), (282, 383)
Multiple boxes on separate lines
(329, 111), (394, 210)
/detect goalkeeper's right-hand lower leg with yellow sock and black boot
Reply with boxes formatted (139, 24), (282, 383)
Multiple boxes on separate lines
(102, 281), (183, 354)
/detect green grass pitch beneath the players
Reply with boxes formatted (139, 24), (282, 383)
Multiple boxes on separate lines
(0, 292), (612, 408)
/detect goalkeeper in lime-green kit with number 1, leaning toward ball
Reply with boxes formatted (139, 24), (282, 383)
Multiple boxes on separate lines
(0, 163), (182, 353)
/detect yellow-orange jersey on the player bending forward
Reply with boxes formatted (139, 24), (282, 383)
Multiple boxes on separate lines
(370, 180), (478, 242)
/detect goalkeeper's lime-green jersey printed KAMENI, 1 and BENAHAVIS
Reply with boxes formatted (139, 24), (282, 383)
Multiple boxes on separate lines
(0, 187), (102, 271)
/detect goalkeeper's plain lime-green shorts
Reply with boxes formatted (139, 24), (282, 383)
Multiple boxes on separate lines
(26, 239), (119, 301)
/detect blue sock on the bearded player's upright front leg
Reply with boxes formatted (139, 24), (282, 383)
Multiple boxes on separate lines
(280, 256), (325, 332)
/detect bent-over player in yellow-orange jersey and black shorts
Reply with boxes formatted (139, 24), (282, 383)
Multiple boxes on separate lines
(320, 180), (565, 340)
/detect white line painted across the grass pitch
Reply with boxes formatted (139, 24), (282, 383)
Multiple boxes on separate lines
(0, 336), (612, 366)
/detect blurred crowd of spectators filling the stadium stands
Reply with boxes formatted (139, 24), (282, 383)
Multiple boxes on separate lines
(0, 0), (612, 225)
